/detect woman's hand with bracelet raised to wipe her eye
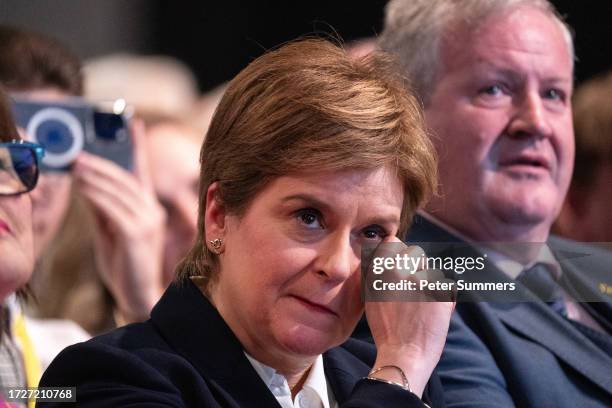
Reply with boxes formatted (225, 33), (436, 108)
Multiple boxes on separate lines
(365, 237), (455, 397)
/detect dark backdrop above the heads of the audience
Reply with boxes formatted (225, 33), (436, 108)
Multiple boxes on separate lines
(0, 0), (612, 91)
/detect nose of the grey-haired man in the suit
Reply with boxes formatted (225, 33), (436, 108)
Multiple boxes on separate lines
(509, 91), (552, 137)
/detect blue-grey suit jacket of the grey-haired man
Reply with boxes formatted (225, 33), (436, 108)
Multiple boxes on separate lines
(408, 217), (612, 408)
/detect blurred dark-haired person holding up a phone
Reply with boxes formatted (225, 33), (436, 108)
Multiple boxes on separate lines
(0, 26), (165, 338)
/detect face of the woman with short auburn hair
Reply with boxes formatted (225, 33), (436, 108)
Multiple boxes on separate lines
(206, 168), (403, 361)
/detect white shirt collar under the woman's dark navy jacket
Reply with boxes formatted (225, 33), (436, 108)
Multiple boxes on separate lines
(244, 352), (338, 408)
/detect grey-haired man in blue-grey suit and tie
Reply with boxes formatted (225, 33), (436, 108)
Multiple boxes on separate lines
(380, 0), (612, 407)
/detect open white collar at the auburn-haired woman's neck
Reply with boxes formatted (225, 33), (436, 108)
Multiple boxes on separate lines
(244, 351), (330, 408)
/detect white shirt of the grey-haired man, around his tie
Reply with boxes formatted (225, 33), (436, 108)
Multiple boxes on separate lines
(419, 211), (604, 332)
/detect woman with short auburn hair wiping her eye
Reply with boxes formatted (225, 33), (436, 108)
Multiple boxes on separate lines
(41, 39), (453, 408)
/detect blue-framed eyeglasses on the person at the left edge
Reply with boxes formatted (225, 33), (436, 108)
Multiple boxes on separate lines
(0, 140), (45, 196)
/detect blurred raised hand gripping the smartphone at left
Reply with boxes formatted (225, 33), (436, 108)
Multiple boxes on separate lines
(74, 121), (166, 323)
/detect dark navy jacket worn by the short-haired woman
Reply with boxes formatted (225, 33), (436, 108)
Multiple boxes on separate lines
(40, 282), (444, 408)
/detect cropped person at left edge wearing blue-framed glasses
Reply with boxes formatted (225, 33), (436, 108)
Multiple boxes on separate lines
(0, 87), (42, 407)
